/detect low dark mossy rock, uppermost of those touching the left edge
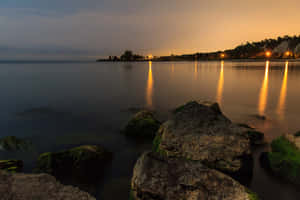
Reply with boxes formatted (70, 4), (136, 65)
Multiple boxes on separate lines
(0, 136), (32, 151)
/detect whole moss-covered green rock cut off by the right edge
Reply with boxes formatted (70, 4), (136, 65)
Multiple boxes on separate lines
(260, 135), (300, 184)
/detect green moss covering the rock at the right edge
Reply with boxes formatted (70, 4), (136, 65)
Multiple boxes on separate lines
(268, 136), (300, 183)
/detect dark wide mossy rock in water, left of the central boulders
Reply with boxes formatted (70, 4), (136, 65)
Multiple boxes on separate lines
(37, 145), (112, 180)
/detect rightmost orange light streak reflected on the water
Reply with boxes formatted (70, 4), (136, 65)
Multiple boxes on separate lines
(277, 61), (289, 119)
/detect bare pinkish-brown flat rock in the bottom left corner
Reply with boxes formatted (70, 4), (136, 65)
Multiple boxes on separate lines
(0, 171), (96, 200)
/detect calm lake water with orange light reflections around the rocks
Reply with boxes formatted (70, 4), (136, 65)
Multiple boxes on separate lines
(0, 61), (300, 200)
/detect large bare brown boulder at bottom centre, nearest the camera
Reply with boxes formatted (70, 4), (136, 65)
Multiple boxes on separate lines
(131, 152), (258, 200)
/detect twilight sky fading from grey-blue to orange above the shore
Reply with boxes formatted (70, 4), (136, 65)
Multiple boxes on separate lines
(0, 0), (300, 60)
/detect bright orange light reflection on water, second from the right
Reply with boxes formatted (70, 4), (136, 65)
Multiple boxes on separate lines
(258, 61), (270, 115)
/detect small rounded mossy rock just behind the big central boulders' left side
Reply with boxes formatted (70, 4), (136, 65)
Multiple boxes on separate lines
(122, 111), (161, 139)
